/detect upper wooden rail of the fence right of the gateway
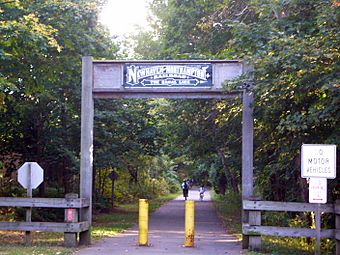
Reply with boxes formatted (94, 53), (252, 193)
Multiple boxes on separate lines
(243, 200), (334, 213)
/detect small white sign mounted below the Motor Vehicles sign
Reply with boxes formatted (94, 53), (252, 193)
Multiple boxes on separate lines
(309, 178), (327, 204)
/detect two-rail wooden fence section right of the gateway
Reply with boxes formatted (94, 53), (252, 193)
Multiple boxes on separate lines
(242, 200), (340, 254)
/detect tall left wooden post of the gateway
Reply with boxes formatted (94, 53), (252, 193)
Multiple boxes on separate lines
(79, 56), (94, 245)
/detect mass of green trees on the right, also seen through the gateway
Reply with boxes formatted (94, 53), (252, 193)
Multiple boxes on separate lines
(144, 0), (340, 201)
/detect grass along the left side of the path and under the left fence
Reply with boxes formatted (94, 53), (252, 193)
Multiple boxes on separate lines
(0, 194), (178, 255)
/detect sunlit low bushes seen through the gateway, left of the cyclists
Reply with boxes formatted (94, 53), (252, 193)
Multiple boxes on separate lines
(95, 152), (180, 208)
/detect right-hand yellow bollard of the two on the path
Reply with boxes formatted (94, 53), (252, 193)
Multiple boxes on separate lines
(184, 200), (195, 247)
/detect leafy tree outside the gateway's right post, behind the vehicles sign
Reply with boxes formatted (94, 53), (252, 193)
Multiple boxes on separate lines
(227, 1), (339, 201)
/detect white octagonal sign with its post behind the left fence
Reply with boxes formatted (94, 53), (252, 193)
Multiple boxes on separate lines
(18, 162), (44, 246)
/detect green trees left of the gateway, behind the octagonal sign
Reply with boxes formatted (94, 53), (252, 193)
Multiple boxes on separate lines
(0, 0), (117, 195)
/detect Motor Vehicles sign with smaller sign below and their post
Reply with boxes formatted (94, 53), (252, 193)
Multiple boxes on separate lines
(301, 144), (336, 255)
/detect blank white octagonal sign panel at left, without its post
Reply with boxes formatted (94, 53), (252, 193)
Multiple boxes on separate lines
(18, 162), (44, 189)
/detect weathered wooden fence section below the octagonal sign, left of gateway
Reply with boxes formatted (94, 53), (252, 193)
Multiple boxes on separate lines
(0, 193), (90, 247)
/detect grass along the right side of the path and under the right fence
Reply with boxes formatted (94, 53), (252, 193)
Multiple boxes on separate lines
(212, 192), (335, 255)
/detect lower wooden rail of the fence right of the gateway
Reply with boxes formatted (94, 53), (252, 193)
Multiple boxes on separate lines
(242, 224), (335, 238)
